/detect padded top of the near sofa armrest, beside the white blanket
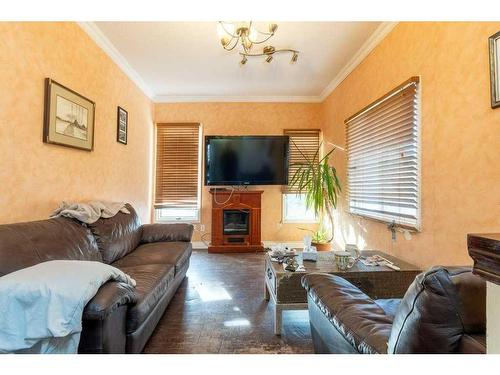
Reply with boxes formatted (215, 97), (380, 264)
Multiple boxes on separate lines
(83, 281), (137, 320)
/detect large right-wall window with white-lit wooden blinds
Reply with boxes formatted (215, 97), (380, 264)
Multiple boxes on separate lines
(345, 77), (420, 229)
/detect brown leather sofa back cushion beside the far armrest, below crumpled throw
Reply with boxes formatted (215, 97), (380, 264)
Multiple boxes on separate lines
(89, 204), (142, 264)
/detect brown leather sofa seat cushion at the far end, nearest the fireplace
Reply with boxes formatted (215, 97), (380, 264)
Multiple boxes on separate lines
(113, 242), (192, 274)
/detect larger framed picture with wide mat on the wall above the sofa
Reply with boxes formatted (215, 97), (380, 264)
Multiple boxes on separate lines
(43, 78), (95, 151)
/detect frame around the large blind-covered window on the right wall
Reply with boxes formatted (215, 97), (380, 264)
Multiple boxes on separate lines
(344, 76), (422, 232)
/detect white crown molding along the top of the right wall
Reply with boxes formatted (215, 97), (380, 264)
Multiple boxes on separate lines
(318, 22), (398, 102)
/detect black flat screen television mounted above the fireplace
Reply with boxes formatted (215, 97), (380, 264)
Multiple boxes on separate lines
(205, 136), (289, 185)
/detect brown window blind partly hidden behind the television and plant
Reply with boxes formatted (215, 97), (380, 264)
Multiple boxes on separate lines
(283, 129), (320, 194)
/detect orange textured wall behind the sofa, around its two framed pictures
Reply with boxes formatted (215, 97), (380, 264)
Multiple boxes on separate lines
(0, 22), (153, 223)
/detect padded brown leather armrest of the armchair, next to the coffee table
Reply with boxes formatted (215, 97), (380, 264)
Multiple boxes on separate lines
(302, 273), (392, 353)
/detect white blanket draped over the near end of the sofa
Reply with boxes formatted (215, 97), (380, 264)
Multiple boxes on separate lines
(0, 260), (135, 354)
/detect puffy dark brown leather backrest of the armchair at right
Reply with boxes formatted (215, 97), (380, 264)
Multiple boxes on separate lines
(389, 267), (486, 353)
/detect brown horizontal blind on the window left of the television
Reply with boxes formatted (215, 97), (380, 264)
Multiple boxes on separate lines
(154, 123), (200, 208)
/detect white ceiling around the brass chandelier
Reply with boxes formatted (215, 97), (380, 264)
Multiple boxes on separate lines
(81, 22), (393, 102)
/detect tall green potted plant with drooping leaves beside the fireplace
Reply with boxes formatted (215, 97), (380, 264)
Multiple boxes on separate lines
(290, 144), (341, 251)
